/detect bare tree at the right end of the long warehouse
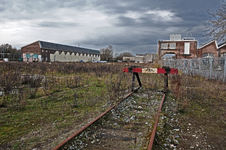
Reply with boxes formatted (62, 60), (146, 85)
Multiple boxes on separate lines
(100, 45), (114, 61)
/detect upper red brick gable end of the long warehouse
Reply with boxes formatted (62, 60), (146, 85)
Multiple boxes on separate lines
(21, 41), (41, 55)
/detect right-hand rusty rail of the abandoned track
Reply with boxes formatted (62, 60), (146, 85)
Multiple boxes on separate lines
(148, 93), (166, 150)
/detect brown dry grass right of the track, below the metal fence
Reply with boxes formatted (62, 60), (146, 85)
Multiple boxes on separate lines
(170, 74), (226, 149)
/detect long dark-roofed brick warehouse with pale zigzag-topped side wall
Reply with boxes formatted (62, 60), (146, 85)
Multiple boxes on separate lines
(21, 41), (100, 62)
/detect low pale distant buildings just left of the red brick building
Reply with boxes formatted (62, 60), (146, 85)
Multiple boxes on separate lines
(123, 53), (157, 63)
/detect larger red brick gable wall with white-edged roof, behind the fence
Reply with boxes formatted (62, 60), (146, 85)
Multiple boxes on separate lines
(198, 41), (218, 58)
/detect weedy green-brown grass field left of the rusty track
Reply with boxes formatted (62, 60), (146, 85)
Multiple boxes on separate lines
(0, 63), (163, 149)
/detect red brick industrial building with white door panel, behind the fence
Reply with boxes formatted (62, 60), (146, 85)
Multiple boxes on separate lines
(158, 34), (226, 59)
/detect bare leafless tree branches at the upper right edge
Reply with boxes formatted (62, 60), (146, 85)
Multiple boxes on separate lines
(205, 1), (226, 42)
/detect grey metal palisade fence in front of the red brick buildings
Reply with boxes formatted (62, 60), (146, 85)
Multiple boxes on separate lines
(159, 57), (226, 82)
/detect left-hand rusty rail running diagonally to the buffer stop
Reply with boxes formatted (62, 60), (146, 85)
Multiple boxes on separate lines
(52, 87), (140, 150)
